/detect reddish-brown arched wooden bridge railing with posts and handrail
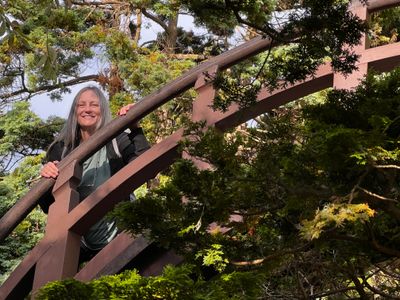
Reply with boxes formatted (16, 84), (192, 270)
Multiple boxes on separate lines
(0, 0), (400, 299)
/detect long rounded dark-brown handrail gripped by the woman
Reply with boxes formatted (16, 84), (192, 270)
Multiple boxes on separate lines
(0, 37), (271, 241)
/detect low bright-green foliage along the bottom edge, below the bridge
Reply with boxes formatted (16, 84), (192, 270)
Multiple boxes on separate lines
(35, 265), (259, 300)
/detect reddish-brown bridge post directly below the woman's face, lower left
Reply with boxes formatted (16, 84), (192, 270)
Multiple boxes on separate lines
(33, 160), (82, 291)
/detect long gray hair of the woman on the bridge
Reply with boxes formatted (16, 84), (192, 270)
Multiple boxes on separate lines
(48, 85), (111, 158)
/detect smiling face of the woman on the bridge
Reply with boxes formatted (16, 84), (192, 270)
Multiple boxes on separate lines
(76, 90), (101, 132)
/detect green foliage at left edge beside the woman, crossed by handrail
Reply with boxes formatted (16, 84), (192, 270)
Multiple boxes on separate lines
(0, 101), (60, 282)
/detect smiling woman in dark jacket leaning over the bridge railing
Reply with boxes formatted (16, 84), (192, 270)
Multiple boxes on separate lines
(39, 86), (149, 261)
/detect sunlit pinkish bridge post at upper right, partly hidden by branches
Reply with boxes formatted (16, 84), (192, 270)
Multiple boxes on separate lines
(333, 0), (369, 90)
